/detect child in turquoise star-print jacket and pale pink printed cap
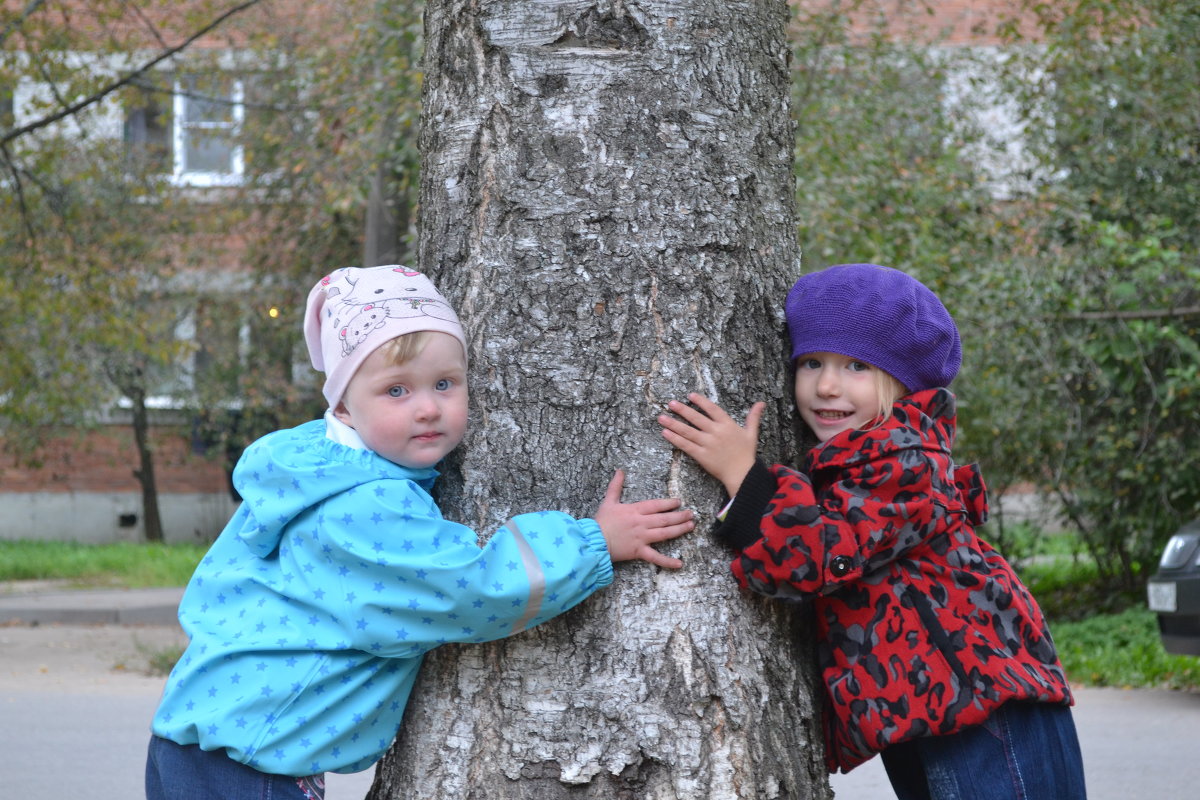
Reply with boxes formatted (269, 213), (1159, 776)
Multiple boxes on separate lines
(146, 266), (692, 800)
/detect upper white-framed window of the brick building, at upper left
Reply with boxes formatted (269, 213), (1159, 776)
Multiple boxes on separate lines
(125, 73), (246, 186)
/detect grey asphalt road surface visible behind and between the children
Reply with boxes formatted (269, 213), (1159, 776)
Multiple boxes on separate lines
(0, 584), (1200, 800)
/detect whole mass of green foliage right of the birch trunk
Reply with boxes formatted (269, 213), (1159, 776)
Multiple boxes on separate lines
(796, 0), (1200, 588)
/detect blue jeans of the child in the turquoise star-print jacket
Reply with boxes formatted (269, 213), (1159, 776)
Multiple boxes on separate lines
(146, 736), (325, 800)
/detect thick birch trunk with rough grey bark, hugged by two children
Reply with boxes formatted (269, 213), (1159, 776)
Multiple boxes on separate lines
(371, 0), (829, 800)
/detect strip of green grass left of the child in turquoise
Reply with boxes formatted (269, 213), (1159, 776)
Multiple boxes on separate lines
(0, 540), (208, 588)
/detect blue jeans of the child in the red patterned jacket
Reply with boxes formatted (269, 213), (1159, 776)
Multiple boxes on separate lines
(881, 702), (1087, 800)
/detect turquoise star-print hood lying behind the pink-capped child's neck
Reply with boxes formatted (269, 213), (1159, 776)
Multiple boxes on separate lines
(233, 420), (438, 558)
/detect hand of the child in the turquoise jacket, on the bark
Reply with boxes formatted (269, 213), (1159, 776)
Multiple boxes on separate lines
(594, 469), (696, 570)
